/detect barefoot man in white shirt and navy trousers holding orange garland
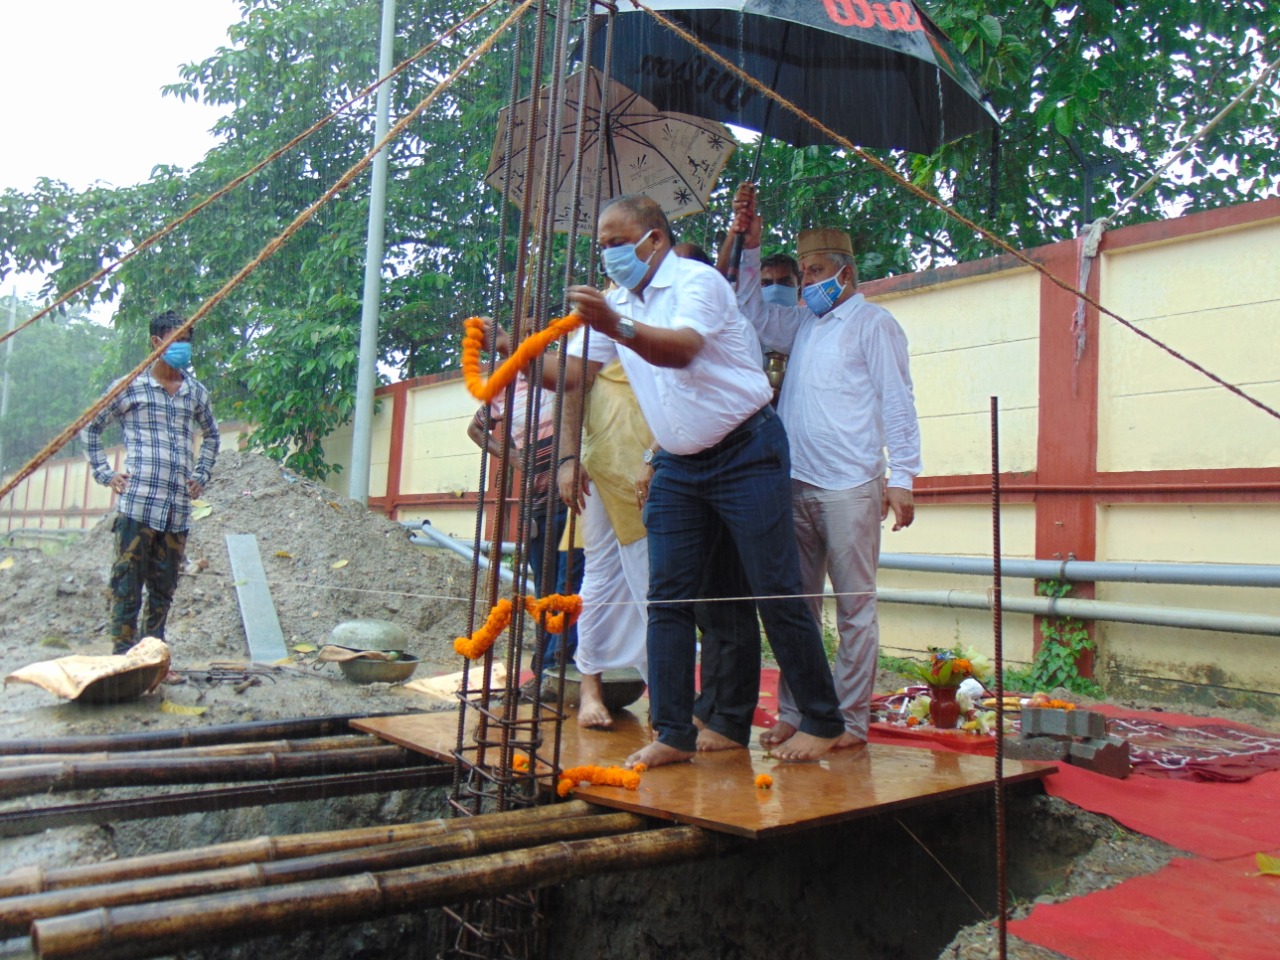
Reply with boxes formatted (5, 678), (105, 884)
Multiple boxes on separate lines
(570, 196), (842, 767)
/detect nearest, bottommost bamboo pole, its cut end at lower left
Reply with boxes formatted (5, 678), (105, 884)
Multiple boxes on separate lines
(31, 827), (737, 960)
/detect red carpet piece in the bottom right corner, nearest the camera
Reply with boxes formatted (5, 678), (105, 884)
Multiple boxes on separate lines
(1009, 856), (1280, 960)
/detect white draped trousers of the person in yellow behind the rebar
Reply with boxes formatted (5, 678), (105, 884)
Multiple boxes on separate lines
(573, 495), (649, 680)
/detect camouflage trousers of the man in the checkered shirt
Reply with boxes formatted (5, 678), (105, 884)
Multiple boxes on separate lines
(110, 515), (187, 653)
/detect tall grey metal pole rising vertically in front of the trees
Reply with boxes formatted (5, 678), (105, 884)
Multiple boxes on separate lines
(347, 0), (396, 503)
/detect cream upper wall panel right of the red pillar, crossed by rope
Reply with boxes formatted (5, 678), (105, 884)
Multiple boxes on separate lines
(1098, 221), (1280, 470)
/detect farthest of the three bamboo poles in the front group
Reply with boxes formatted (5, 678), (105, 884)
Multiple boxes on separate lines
(0, 800), (603, 897)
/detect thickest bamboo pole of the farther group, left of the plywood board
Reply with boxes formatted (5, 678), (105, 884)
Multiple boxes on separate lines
(0, 746), (426, 799)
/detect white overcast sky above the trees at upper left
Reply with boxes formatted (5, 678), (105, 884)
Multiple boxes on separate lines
(0, 0), (239, 294)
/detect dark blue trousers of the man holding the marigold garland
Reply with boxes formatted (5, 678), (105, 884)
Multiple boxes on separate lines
(644, 407), (844, 751)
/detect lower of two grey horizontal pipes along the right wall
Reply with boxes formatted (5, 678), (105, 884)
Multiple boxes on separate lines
(876, 588), (1280, 636)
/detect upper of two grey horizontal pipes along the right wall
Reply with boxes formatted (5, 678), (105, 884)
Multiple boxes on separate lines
(879, 553), (1280, 586)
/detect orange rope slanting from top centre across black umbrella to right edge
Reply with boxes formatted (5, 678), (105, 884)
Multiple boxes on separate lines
(631, 0), (1280, 420)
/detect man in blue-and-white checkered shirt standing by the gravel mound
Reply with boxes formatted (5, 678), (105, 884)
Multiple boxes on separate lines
(81, 311), (219, 654)
